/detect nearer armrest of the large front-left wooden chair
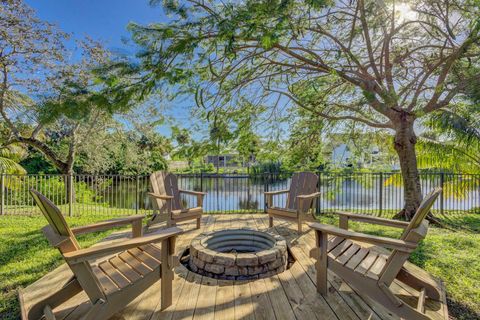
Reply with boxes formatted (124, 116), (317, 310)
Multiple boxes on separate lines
(63, 227), (183, 264)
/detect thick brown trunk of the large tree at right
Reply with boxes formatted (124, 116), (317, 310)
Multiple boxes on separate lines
(394, 114), (422, 220)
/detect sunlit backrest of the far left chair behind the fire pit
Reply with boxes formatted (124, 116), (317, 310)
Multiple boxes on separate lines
(150, 171), (183, 211)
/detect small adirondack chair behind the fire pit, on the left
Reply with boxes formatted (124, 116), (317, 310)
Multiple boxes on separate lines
(147, 171), (206, 229)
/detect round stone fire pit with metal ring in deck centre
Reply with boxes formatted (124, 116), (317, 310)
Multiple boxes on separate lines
(188, 229), (288, 280)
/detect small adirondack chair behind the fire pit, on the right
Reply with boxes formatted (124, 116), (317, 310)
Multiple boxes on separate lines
(265, 172), (320, 232)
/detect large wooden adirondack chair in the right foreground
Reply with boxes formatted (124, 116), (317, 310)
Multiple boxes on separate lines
(310, 188), (441, 320)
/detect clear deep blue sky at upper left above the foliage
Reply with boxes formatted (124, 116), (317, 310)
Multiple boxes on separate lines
(25, 0), (197, 136)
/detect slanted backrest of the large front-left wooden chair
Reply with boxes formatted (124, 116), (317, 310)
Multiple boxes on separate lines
(30, 189), (80, 253)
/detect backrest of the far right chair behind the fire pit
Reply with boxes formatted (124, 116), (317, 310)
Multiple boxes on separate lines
(287, 172), (318, 210)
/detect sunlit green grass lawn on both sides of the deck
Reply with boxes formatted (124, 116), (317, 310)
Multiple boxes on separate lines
(0, 213), (480, 320)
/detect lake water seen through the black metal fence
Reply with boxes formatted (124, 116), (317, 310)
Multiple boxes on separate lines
(100, 176), (480, 212)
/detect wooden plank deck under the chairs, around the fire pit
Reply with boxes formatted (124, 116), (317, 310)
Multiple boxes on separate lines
(20, 214), (448, 320)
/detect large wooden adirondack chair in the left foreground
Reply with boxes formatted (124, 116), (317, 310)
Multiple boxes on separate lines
(23, 189), (182, 320)
